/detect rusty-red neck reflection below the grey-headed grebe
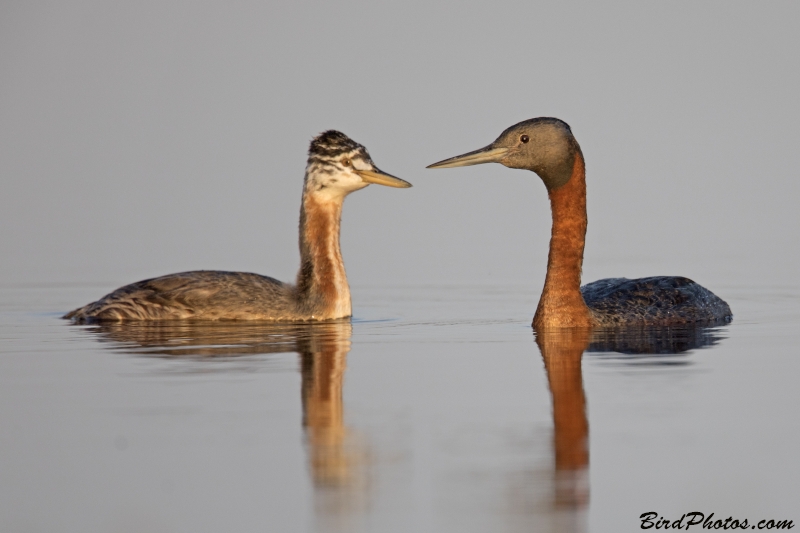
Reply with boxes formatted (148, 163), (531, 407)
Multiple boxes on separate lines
(536, 328), (591, 505)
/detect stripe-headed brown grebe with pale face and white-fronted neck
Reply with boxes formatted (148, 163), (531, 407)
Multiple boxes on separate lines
(64, 130), (411, 322)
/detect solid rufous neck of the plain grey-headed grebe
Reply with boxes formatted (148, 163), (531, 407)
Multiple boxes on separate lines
(533, 151), (591, 328)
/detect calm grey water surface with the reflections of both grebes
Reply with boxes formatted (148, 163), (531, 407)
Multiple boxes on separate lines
(0, 284), (800, 533)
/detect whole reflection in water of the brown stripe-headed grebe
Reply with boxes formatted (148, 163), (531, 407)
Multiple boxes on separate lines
(79, 319), (369, 530)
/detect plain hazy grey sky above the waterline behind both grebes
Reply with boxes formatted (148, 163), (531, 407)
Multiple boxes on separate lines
(0, 0), (800, 290)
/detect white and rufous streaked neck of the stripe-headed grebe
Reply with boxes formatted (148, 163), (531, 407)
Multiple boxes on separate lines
(297, 191), (351, 319)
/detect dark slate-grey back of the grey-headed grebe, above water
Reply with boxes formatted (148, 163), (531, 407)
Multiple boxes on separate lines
(581, 276), (733, 326)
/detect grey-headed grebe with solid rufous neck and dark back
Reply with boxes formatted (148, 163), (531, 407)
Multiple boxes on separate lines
(428, 117), (733, 329)
